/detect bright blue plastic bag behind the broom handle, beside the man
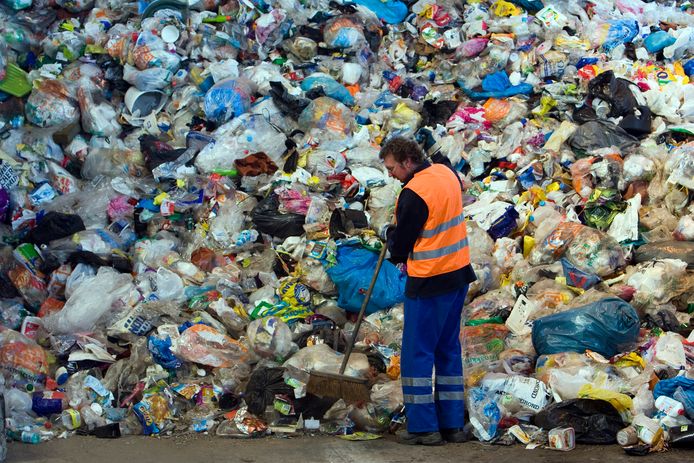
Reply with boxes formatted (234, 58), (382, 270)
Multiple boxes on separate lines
(326, 245), (407, 314)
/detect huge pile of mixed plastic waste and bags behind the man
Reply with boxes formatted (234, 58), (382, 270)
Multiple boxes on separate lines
(0, 0), (694, 454)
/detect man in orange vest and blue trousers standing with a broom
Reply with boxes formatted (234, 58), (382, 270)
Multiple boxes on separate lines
(380, 136), (476, 445)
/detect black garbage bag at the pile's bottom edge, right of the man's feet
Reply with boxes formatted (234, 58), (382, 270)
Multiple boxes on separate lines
(533, 399), (625, 444)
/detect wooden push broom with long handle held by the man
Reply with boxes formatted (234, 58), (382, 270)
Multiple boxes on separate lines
(306, 243), (388, 402)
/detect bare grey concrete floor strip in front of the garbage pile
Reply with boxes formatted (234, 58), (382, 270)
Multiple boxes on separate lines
(7, 435), (694, 463)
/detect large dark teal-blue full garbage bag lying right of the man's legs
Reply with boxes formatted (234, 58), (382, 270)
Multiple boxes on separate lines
(532, 297), (640, 357)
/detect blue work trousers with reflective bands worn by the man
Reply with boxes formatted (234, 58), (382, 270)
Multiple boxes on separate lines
(400, 286), (468, 432)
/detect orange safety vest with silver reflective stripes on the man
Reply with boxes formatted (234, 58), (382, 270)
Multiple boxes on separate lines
(405, 164), (470, 278)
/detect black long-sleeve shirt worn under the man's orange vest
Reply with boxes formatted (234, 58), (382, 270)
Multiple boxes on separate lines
(387, 162), (477, 298)
